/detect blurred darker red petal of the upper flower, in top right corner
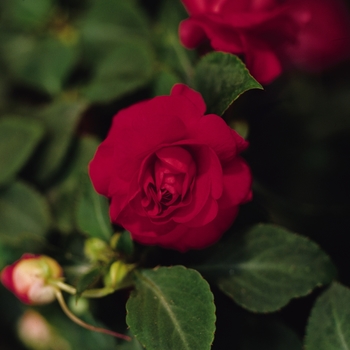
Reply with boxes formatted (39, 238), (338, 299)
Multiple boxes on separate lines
(284, 0), (350, 72)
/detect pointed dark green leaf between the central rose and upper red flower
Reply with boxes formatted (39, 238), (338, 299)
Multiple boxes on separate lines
(194, 52), (262, 115)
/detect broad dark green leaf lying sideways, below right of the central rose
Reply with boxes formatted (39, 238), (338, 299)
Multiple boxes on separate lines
(196, 224), (335, 312)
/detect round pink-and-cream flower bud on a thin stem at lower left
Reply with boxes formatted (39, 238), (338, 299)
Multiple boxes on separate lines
(1, 254), (63, 304)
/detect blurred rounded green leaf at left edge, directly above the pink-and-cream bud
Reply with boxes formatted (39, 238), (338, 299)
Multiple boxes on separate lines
(0, 182), (50, 249)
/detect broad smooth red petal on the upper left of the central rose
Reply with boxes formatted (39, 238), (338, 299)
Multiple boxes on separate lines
(104, 96), (201, 181)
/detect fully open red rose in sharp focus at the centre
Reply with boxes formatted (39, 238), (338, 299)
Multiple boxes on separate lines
(90, 84), (252, 251)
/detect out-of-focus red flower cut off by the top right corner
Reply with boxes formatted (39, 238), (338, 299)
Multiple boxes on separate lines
(180, 0), (350, 83)
